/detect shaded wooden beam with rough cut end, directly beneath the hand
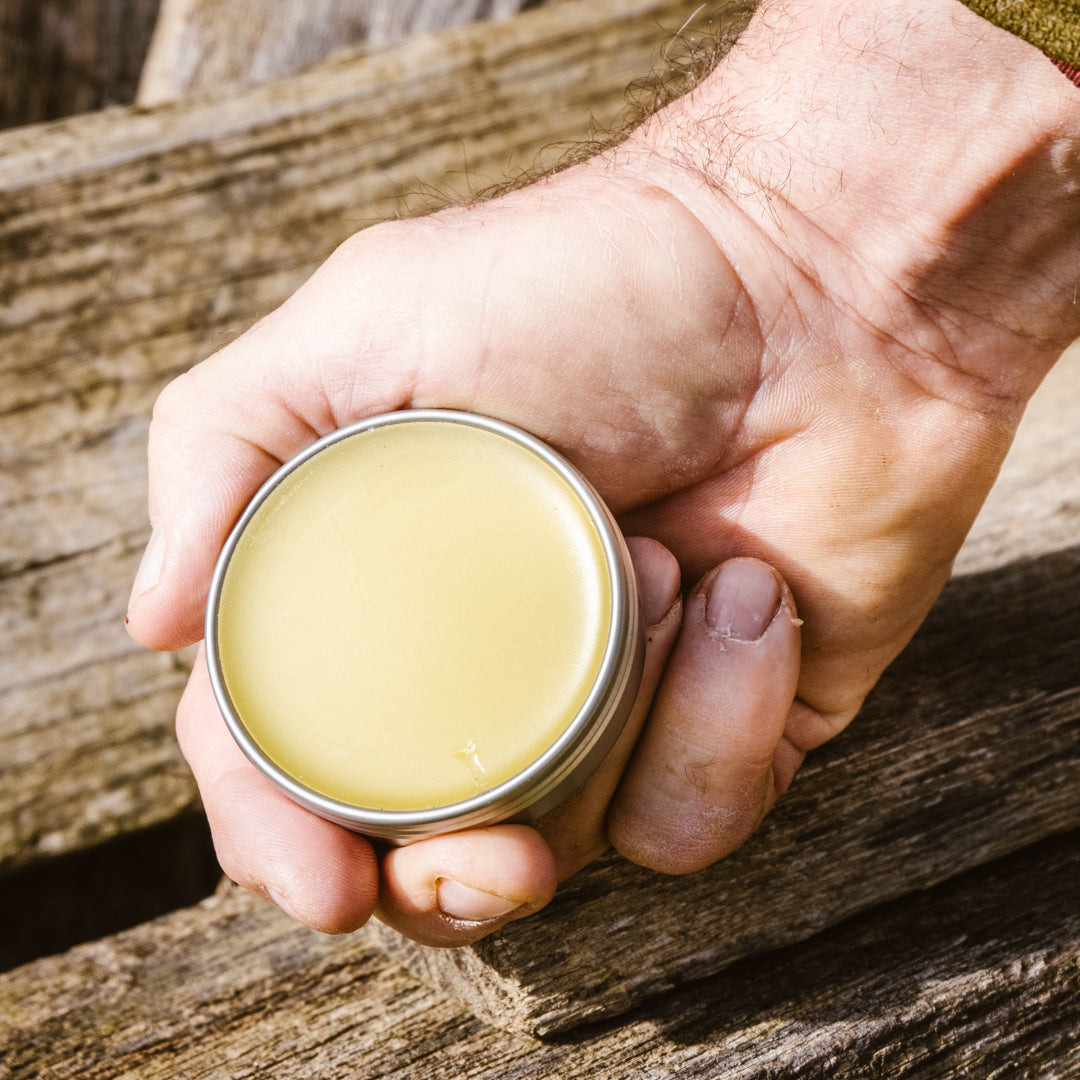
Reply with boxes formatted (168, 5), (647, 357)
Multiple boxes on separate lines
(367, 486), (1080, 1032)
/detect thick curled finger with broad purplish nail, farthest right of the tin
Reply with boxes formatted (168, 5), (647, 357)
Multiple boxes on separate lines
(608, 558), (799, 874)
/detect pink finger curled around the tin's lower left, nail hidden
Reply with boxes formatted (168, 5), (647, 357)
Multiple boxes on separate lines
(177, 652), (378, 933)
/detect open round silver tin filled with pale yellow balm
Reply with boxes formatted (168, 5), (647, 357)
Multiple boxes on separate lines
(206, 409), (644, 843)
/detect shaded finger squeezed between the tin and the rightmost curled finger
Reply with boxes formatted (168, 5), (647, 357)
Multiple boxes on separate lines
(537, 537), (683, 881)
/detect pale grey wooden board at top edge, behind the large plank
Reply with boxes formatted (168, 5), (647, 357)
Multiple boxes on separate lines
(137, 0), (543, 105)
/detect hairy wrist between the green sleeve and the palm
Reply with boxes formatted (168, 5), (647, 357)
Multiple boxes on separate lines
(632, 0), (1080, 400)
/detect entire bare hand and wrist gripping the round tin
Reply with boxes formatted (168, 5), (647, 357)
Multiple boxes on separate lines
(129, 0), (1080, 945)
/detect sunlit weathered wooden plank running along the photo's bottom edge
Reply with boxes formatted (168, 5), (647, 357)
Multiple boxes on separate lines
(0, 834), (1080, 1080)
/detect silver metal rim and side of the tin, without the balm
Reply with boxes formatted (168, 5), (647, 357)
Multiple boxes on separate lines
(205, 409), (644, 843)
